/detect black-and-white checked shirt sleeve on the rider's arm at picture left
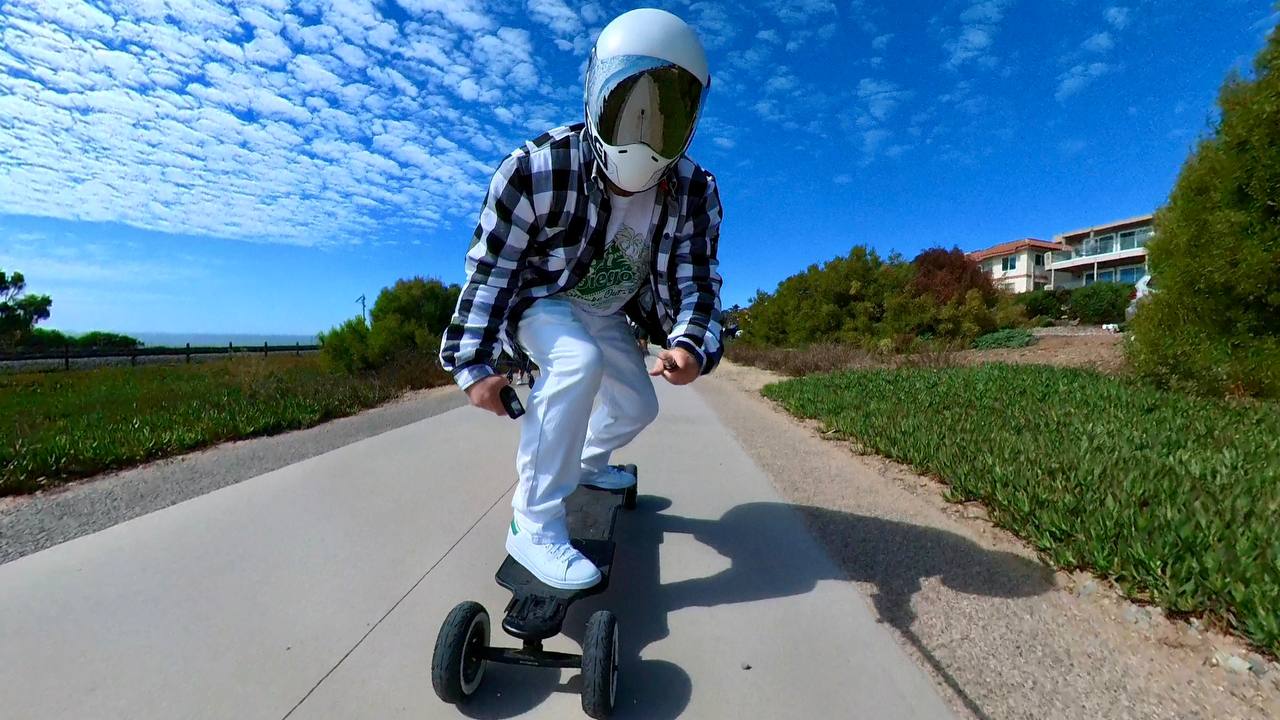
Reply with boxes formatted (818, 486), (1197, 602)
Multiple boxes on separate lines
(440, 152), (535, 389)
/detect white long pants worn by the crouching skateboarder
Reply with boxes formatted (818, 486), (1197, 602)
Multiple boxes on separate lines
(511, 297), (658, 544)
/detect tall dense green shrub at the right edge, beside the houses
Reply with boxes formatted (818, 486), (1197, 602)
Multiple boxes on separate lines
(1129, 22), (1280, 398)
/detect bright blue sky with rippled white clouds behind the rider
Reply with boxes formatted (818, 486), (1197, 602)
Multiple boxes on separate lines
(0, 0), (1277, 333)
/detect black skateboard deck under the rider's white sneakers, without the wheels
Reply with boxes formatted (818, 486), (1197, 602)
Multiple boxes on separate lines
(494, 465), (636, 641)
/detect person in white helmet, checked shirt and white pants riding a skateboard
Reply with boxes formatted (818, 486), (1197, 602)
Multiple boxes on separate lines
(440, 9), (722, 589)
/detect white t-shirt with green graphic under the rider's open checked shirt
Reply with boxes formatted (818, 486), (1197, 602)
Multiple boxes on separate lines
(564, 187), (658, 315)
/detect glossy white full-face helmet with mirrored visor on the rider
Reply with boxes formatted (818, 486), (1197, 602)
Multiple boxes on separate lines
(585, 9), (712, 192)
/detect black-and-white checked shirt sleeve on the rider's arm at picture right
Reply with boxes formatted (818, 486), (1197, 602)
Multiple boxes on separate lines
(667, 170), (723, 375)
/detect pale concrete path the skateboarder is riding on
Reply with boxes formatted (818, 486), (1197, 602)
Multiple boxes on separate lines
(0, 383), (948, 720)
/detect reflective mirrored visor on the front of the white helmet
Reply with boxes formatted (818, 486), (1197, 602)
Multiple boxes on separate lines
(586, 55), (704, 159)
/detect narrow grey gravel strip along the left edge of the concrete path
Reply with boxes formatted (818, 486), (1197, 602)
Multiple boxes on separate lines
(0, 386), (466, 564)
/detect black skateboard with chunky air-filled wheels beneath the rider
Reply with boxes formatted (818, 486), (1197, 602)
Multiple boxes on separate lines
(431, 461), (637, 720)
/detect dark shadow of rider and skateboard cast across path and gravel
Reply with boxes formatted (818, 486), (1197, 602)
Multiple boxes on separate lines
(463, 496), (1052, 719)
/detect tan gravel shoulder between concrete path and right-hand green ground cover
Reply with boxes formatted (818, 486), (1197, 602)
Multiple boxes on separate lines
(696, 363), (1280, 720)
